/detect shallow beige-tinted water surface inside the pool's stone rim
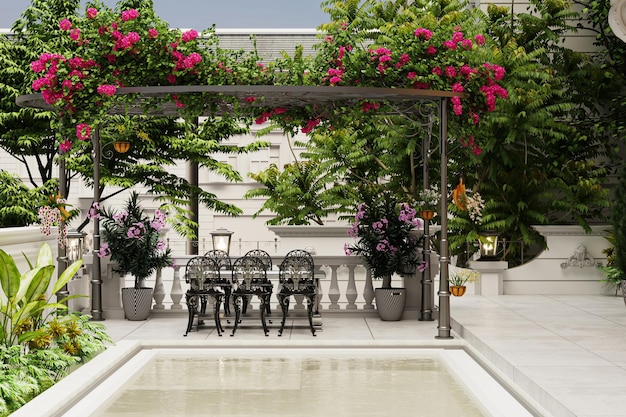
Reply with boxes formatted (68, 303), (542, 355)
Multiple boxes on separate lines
(92, 349), (490, 417)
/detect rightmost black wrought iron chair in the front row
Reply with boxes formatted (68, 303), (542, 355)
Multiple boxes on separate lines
(277, 249), (317, 336)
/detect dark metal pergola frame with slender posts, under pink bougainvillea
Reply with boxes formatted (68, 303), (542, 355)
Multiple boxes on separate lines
(16, 85), (464, 339)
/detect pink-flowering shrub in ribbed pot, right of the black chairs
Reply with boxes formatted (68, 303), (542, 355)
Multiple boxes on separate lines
(344, 192), (423, 320)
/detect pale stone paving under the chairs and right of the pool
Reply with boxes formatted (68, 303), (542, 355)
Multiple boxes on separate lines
(103, 295), (626, 417)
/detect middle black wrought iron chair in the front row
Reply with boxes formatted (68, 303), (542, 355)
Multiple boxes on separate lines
(231, 256), (272, 336)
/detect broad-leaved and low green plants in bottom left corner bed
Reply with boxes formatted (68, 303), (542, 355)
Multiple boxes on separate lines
(0, 243), (111, 416)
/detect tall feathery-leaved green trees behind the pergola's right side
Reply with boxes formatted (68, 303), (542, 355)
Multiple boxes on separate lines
(245, 0), (610, 265)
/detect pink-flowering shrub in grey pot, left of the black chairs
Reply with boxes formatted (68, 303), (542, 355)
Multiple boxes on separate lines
(98, 192), (173, 320)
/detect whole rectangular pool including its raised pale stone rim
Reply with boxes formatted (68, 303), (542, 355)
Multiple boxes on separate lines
(12, 342), (531, 417)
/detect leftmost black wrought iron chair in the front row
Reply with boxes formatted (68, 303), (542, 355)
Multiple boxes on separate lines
(185, 256), (224, 336)
